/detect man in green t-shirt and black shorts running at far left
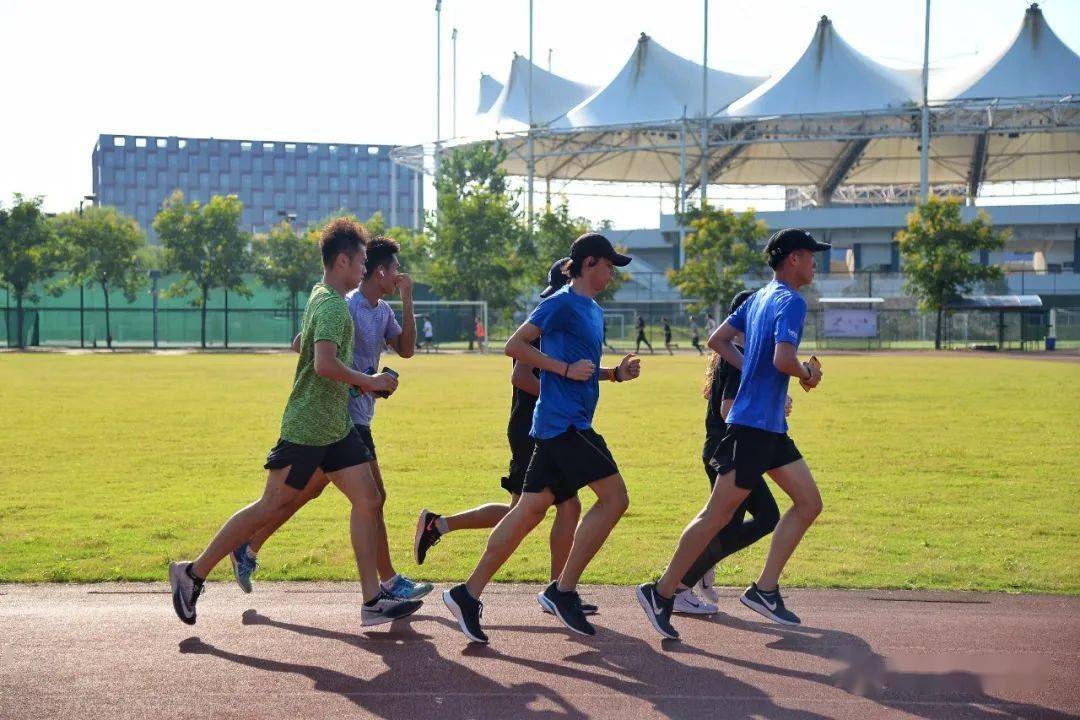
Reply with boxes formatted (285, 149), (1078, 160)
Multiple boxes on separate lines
(168, 218), (422, 625)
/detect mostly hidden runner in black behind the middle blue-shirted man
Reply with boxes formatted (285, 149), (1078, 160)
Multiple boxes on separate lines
(413, 258), (596, 614)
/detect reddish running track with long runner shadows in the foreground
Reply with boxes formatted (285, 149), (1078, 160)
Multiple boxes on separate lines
(0, 583), (1080, 720)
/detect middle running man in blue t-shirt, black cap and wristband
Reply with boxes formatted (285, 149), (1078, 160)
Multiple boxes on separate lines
(443, 233), (640, 642)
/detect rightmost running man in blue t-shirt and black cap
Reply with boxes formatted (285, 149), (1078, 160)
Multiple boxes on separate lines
(637, 230), (831, 639)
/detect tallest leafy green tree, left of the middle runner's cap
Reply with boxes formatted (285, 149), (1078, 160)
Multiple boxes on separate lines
(426, 144), (536, 311)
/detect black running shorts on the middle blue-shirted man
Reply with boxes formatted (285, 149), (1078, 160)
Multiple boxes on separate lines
(523, 427), (619, 505)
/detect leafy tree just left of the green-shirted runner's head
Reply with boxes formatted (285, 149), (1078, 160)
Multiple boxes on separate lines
(252, 221), (322, 338)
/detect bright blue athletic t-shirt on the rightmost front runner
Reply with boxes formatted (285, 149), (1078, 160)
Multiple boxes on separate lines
(727, 280), (807, 433)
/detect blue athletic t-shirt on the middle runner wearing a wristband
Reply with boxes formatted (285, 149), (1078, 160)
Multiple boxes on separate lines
(526, 285), (604, 440)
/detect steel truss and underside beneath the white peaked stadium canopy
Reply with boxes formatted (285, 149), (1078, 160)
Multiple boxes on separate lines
(392, 95), (1080, 197)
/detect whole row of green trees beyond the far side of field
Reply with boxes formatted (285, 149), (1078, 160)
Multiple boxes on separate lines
(0, 144), (1008, 348)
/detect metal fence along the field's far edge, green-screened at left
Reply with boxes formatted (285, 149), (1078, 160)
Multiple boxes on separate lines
(0, 273), (1080, 349)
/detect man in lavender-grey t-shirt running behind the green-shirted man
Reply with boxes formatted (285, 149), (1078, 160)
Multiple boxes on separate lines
(232, 237), (432, 599)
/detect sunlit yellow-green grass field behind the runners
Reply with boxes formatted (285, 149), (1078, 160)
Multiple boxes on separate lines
(0, 354), (1080, 594)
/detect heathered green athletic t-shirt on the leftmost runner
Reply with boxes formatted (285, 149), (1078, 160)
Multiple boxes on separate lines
(281, 283), (353, 446)
